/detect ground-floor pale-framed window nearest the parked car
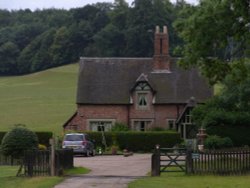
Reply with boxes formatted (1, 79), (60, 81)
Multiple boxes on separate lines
(88, 119), (115, 131)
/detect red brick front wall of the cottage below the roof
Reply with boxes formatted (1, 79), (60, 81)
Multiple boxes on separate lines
(65, 104), (184, 130)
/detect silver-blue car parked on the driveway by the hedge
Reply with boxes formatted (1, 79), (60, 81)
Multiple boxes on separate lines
(62, 133), (95, 157)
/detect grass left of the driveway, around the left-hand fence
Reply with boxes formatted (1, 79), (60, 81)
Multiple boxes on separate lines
(0, 166), (90, 188)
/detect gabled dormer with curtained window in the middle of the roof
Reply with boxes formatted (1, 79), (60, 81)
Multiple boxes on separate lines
(130, 73), (155, 110)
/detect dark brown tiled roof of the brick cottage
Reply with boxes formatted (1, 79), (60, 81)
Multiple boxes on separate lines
(77, 58), (212, 104)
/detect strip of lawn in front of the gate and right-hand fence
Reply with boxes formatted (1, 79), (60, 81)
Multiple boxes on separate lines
(129, 173), (250, 188)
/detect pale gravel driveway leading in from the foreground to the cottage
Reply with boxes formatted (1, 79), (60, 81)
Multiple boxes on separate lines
(55, 154), (151, 188)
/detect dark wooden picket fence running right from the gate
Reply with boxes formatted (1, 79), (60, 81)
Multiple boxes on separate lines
(187, 149), (250, 175)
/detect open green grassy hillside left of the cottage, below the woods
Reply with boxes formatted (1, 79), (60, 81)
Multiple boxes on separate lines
(0, 64), (78, 134)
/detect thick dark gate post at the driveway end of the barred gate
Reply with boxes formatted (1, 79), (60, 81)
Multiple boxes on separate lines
(151, 145), (161, 176)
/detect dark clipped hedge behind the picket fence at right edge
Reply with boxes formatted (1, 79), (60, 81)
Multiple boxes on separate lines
(207, 126), (250, 147)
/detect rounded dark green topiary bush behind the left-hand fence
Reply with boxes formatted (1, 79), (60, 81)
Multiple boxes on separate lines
(1, 127), (38, 159)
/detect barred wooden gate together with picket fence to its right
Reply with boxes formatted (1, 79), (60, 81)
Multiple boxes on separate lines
(151, 148), (250, 176)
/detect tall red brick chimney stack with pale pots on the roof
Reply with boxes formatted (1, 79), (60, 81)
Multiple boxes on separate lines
(154, 26), (170, 72)
